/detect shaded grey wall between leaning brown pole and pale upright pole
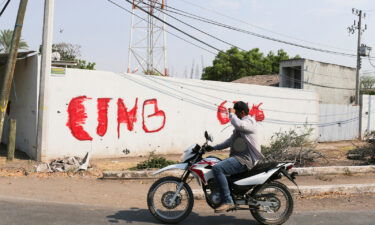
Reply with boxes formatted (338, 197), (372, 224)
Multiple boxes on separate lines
(2, 55), (39, 158)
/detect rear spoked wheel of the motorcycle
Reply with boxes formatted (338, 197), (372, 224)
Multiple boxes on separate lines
(250, 181), (293, 225)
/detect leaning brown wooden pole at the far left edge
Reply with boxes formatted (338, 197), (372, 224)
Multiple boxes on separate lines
(0, 0), (28, 143)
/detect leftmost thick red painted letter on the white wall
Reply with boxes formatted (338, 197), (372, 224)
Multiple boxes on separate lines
(66, 96), (92, 141)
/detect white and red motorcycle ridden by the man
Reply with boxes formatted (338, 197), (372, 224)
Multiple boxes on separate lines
(147, 131), (298, 225)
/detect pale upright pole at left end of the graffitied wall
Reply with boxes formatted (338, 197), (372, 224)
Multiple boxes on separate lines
(37, 0), (55, 161)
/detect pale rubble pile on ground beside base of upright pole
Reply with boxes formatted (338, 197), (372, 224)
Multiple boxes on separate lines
(36, 153), (90, 173)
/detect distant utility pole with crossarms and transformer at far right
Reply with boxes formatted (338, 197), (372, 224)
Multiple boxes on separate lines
(348, 8), (367, 139)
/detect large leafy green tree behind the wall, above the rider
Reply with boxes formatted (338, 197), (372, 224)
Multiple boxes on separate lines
(202, 47), (299, 81)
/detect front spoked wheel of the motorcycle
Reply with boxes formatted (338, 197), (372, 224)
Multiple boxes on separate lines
(147, 177), (194, 223)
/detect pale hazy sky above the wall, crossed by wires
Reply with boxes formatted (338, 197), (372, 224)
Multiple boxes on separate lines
(0, 0), (375, 76)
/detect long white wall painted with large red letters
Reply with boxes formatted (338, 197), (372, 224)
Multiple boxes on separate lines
(38, 69), (319, 160)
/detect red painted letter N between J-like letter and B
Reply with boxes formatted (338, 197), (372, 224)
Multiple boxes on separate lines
(117, 98), (138, 138)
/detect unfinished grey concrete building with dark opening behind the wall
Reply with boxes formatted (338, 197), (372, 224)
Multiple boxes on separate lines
(279, 59), (356, 104)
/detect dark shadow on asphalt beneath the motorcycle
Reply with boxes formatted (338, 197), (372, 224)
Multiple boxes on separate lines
(107, 208), (259, 225)
